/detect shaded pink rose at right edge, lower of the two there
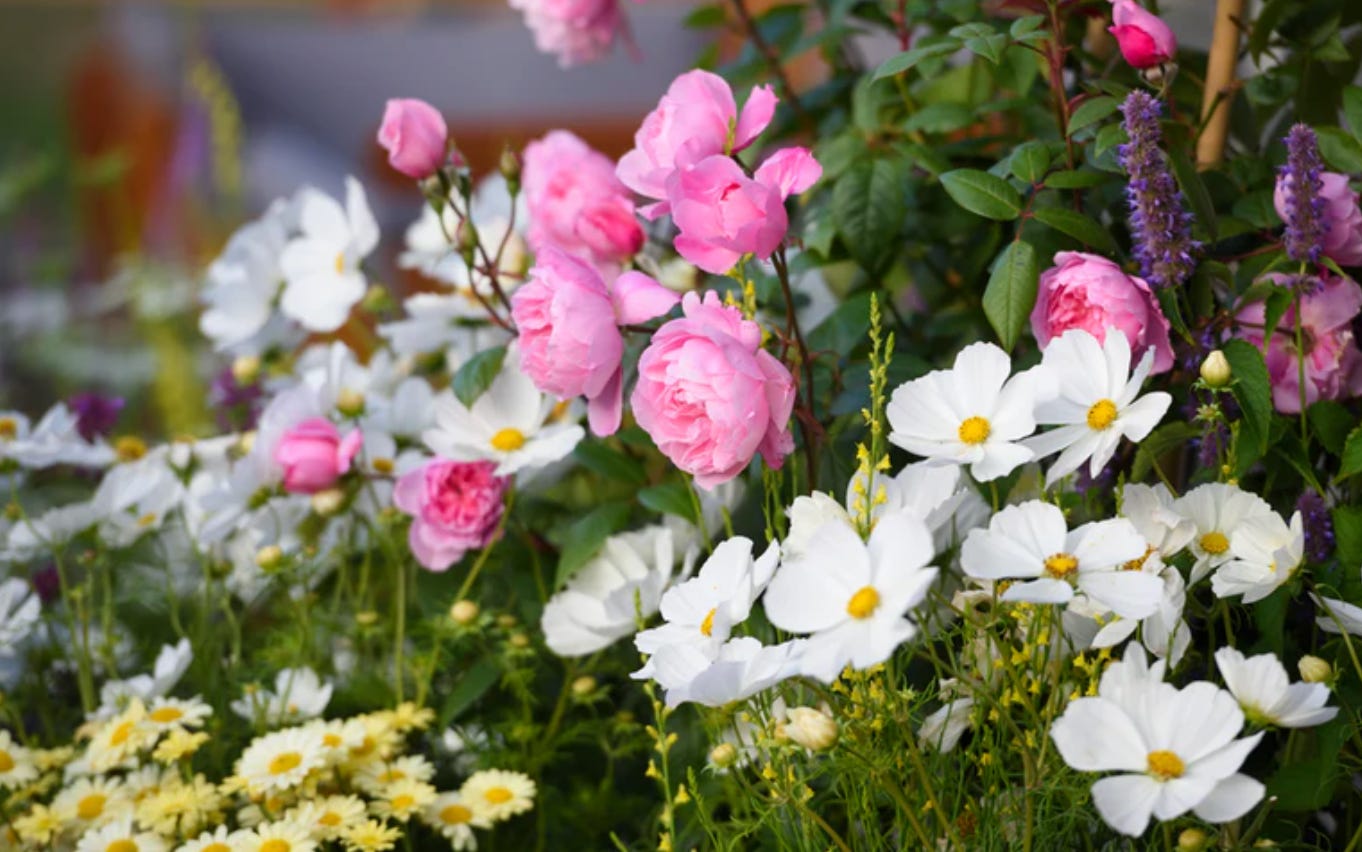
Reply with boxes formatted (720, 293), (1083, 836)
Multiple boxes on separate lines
(1235, 275), (1362, 414)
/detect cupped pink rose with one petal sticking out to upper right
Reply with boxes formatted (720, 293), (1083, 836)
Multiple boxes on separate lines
(667, 148), (823, 275)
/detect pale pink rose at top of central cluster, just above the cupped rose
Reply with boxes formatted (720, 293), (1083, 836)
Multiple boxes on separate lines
(617, 71), (776, 219)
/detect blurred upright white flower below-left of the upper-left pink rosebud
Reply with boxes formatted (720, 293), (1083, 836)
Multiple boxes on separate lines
(279, 177), (379, 331)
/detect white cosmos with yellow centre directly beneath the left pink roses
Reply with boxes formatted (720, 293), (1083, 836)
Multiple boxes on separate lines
(422, 346), (586, 476)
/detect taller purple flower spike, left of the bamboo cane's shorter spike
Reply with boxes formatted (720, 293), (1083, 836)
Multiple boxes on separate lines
(1120, 91), (1201, 289)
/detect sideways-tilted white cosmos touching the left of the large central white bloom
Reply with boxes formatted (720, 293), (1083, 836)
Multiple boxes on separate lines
(632, 536), (780, 679)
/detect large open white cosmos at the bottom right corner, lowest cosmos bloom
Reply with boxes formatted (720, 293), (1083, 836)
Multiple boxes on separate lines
(1050, 645), (1264, 837)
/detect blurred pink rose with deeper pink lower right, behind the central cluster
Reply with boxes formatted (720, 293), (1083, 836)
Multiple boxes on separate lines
(523, 131), (643, 274)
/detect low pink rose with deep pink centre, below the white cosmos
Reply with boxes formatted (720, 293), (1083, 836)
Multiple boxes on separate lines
(392, 459), (511, 572)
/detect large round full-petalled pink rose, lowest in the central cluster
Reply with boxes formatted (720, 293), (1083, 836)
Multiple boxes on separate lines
(629, 291), (794, 489)
